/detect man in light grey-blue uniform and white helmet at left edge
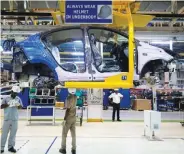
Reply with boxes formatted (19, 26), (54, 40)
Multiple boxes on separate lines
(1, 86), (23, 153)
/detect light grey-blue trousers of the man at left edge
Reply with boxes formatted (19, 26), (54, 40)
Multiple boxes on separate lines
(1, 120), (18, 150)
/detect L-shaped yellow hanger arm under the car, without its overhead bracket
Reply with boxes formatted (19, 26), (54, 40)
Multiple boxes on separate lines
(65, 3), (134, 89)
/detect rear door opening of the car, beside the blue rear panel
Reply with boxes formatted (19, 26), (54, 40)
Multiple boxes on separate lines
(41, 29), (85, 73)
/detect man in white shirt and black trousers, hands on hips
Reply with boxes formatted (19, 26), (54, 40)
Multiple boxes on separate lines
(109, 89), (123, 122)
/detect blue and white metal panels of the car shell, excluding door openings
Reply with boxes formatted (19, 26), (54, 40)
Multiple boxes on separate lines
(13, 26), (173, 81)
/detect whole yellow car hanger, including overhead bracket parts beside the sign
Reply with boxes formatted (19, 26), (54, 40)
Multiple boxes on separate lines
(51, 0), (153, 89)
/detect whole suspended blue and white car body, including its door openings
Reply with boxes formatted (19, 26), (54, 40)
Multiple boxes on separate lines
(12, 26), (174, 85)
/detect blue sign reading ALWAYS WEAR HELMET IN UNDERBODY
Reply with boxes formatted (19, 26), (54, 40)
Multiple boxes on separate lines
(65, 0), (113, 24)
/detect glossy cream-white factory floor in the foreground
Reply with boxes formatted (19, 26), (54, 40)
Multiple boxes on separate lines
(0, 121), (184, 154)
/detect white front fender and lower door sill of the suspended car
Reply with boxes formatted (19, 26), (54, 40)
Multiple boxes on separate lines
(56, 42), (173, 81)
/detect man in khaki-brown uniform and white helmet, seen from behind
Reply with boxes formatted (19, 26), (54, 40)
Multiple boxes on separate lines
(59, 88), (77, 154)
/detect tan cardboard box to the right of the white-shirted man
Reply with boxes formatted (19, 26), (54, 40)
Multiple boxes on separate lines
(133, 99), (151, 110)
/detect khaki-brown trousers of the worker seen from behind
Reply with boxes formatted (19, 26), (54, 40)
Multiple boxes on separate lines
(61, 117), (76, 150)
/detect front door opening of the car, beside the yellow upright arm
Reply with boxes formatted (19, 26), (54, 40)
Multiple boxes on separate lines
(88, 28), (128, 72)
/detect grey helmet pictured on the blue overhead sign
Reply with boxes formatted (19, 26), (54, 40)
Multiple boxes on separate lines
(98, 5), (112, 19)
